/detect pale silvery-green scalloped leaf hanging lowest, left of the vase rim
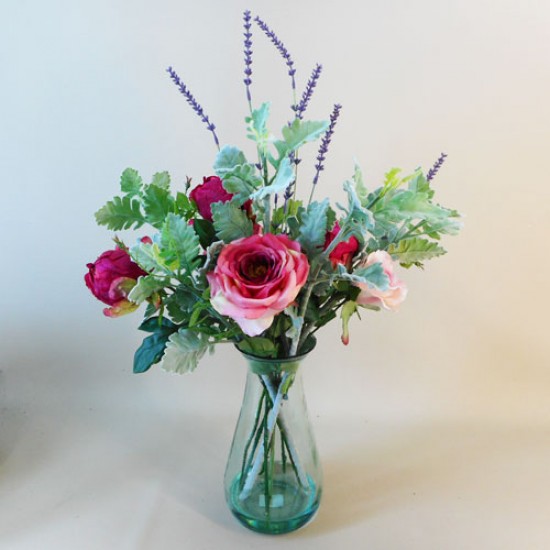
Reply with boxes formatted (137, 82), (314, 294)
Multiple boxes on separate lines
(160, 329), (212, 374)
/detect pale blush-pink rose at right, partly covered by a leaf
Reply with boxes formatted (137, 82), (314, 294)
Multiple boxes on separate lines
(356, 250), (407, 311)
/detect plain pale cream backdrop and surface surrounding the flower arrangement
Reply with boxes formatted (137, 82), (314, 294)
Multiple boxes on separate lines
(0, 0), (550, 550)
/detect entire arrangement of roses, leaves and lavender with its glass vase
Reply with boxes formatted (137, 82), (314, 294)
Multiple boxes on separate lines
(85, 11), (460, 533)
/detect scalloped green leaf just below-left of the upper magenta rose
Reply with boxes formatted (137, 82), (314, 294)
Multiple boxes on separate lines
(161, 213), (200, 274)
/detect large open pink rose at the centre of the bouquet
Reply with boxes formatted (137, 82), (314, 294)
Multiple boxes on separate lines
(206, 233), (309, 336)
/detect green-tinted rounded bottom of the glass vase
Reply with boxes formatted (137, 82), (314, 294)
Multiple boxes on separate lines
(228, 476), (321, 535)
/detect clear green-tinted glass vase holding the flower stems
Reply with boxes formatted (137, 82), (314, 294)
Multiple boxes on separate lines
(225, 353), (322, 534)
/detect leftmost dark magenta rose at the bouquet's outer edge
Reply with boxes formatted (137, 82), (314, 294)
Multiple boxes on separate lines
(84, 248), (147, 317)
